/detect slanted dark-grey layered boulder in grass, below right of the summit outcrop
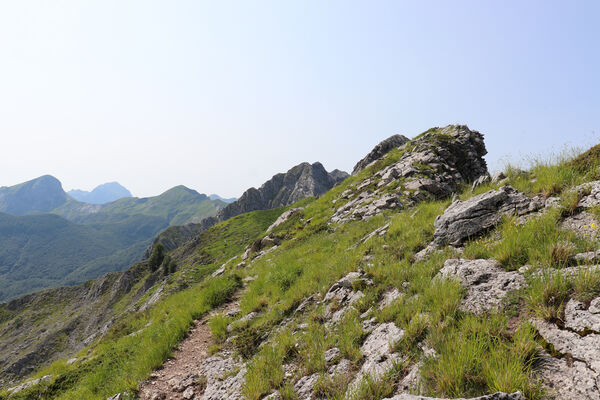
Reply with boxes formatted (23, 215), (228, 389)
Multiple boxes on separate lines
(433, 186), (545, 246)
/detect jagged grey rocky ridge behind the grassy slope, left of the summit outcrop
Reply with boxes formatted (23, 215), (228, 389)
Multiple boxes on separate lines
(144, 162), (349, 258)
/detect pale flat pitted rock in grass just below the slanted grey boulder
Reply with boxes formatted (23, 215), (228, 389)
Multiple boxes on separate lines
(438, 259), (525, 314)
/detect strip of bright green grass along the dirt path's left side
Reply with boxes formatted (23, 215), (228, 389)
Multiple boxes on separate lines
(2, 277), (240, 400)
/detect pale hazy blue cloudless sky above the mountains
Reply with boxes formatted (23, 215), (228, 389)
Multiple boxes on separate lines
(0, 0), (600, 197)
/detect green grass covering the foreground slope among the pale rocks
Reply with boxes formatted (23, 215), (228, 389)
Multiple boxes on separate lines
(0, 142), (600, 399)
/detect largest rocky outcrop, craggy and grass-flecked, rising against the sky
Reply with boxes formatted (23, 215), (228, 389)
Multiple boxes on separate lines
(331, 125), (487, 222)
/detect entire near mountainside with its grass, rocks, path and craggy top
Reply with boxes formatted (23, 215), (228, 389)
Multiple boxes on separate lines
(0, 125), (600, 400)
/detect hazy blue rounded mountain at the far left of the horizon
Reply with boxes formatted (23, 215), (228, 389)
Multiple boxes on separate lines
(0, 175), (68, 215)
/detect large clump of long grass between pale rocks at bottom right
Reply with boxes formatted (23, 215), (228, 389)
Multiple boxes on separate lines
(422, 315), (543, 399)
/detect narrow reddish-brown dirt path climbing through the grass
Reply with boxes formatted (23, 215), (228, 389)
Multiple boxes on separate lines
(139, 292), (241, 400)
